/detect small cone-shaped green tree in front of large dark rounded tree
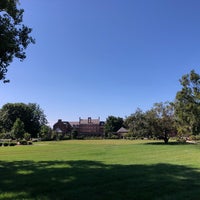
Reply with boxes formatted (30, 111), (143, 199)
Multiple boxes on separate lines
(11, 118), (25, 139)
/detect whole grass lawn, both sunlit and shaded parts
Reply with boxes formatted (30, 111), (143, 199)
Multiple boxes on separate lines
(0, 140), (200, 200)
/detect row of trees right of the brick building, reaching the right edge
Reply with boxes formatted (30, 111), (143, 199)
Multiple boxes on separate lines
(105, 70), (200, 143)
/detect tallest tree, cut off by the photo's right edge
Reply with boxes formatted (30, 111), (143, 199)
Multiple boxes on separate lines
(175, 70), (200, 135)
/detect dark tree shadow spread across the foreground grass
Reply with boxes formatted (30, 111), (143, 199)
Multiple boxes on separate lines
(0, 160), (200, 200)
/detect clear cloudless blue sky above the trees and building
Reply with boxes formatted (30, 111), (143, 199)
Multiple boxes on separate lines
(0, 0), (200, 125)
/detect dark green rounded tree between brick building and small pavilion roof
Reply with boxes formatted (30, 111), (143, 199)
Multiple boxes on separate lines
(104, 116), (124, 135)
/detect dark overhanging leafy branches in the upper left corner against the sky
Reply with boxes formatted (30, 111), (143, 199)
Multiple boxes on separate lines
(0, 0), (35, 82)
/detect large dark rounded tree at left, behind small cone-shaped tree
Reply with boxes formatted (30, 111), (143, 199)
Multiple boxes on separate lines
(0, 103), (47, 137)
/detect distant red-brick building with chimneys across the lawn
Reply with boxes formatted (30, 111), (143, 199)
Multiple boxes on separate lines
(53, 117), (105, 136)
